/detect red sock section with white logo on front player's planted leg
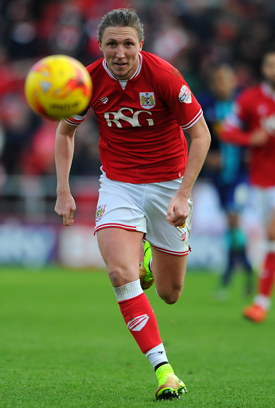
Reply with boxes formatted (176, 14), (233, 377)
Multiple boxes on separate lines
(118, 293), (162, 354)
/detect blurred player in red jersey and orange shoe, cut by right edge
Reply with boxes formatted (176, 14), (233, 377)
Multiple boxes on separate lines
(222, 48), (275, 323)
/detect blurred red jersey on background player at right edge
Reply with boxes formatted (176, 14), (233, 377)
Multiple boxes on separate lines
(221, 83), (275, 188)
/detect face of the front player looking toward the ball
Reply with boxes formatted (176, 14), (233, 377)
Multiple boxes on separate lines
(98, 27), (143, 80)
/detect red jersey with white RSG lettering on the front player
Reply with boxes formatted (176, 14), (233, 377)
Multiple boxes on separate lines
(66, 52), (202, 183)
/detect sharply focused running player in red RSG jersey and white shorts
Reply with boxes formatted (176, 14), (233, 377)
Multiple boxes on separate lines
(55, 9), (210, 399)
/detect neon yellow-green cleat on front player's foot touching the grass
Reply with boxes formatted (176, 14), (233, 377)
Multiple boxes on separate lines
(156, 364), (187, 400)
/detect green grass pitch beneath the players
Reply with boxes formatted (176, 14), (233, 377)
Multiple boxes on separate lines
(0, 267), (275, 408)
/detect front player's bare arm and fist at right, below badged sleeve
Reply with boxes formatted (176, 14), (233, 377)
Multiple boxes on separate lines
(167, 117), (211, 227)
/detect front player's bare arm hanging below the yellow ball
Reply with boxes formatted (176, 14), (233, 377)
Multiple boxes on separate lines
(55, 121), (76, 226)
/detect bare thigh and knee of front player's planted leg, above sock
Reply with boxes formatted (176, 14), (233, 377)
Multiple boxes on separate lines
(97, 228), (143, 287)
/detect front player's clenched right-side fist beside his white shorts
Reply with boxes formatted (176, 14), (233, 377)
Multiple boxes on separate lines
(166, 193), (189, 227)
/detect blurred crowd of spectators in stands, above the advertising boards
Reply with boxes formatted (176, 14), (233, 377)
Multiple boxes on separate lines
(0, 0), (275, 176)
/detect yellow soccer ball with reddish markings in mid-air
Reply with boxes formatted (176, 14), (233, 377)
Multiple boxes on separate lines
(25, 55), (92, 120)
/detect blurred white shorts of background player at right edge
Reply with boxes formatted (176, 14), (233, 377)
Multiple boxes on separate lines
(253, 187), (275, 225)
